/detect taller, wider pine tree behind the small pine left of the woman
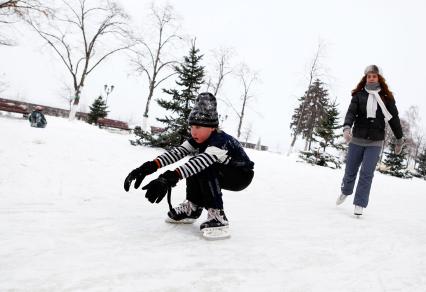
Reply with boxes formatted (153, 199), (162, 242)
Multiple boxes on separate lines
(290, 79), (329, 150)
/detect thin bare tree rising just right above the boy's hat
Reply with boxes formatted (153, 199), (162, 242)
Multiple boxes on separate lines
(207, 48), (234, 96)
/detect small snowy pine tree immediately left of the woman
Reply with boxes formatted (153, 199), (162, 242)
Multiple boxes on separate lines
(312, 101), (343, 152)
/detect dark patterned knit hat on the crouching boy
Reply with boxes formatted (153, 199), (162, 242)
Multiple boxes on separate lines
(188, 92), (219, 128)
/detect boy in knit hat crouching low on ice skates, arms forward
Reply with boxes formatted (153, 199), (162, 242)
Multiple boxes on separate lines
(124, 93), (254, 237)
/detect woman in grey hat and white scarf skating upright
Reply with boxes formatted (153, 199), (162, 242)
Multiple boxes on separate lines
(336, 65), (403, 216)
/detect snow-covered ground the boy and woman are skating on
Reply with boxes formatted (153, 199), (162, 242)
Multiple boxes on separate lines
(0, 116), (426, 291)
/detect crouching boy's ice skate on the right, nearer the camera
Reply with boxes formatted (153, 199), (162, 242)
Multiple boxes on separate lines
(200, 208), (231, 239)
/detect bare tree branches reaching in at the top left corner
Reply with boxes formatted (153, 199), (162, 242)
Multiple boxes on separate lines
(0, 0), (50, 46)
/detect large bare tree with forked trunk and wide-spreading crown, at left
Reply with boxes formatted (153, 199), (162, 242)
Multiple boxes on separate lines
(28, 0), (130, 120)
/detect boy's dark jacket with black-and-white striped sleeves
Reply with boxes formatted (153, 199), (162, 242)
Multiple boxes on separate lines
(156, 131), (254, 178)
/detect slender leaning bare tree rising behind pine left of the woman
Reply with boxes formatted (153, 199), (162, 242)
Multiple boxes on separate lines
(287, 41), (325, 155)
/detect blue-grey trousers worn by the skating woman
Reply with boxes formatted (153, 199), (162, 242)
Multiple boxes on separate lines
(341, 143), (382, 208)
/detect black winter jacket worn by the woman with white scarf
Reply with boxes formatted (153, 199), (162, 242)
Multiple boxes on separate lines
(343, 89), (403, 141)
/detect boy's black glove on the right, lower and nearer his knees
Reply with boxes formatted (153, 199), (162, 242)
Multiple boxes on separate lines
(142, 170), (179, 204)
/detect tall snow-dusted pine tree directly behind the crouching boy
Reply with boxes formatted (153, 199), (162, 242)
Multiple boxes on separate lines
(145, 41), (204, 148)
